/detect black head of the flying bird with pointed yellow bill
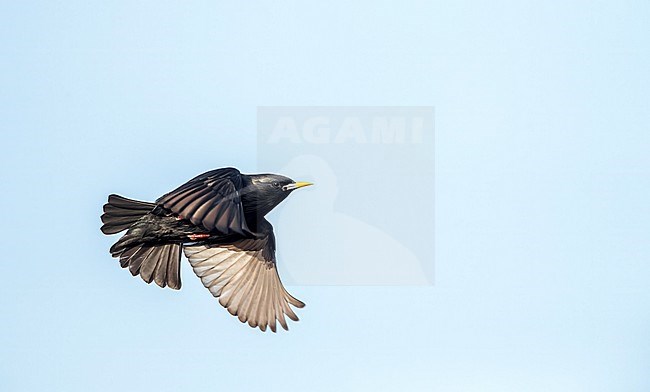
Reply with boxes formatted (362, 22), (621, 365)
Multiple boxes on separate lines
(242, 174), (313, 216)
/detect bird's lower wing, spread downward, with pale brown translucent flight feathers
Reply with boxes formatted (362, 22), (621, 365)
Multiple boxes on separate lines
(184, 224), (305, 332)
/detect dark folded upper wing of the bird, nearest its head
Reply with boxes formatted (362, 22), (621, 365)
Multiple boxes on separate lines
(156, 168), (251, 235)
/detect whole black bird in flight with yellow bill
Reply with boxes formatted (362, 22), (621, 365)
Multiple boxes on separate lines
(101, 168), (312, 332)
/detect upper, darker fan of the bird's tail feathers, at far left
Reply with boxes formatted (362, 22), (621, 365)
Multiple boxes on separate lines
(101, 195), (156, 234)
